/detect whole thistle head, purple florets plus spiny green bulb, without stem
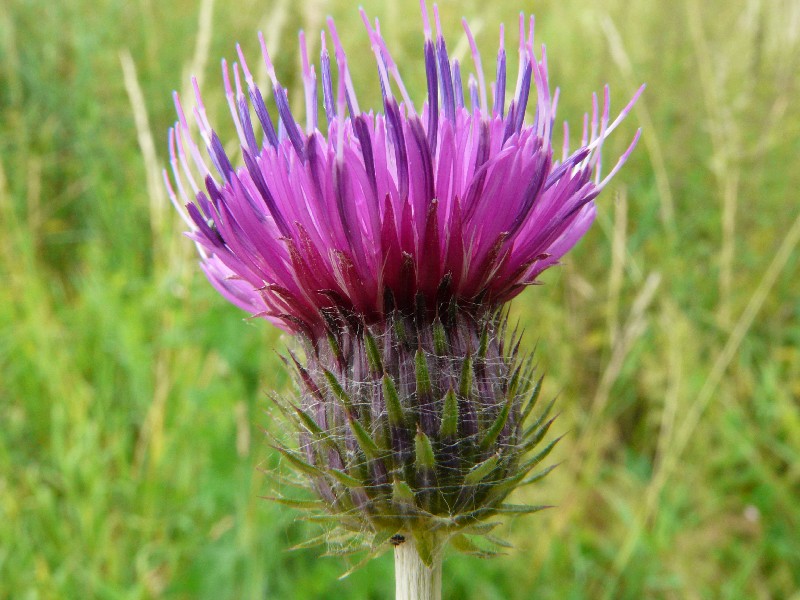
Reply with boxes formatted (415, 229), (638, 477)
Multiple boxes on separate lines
(165, 0), (641, 596)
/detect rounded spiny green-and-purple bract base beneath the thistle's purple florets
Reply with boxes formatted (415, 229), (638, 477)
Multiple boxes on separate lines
(278, 310), (557, 562)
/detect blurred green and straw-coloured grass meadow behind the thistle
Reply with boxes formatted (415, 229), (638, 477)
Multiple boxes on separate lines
(0, 0), (800, 599)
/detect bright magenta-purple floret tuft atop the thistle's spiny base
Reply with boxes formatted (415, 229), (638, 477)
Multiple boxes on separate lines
(165, 0), (641, 338)
